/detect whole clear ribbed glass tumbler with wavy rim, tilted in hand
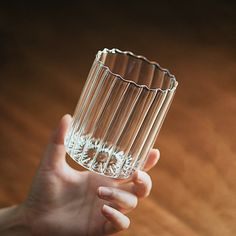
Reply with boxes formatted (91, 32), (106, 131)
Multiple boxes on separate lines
(65, 48), (178, 178)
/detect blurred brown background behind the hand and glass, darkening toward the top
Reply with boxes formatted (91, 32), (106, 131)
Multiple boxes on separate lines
(0, 1), (236, 236)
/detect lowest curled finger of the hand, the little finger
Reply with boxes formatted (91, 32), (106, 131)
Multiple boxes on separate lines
(102, 205), (130, 234)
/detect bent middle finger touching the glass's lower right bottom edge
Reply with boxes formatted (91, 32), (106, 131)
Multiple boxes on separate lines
(119, 170), (152, 198)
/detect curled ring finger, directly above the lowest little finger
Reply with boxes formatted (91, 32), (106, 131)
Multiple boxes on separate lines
(98, 187), (138, 213)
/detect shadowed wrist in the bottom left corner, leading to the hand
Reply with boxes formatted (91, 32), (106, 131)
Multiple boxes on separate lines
(0, 205), (31, 236)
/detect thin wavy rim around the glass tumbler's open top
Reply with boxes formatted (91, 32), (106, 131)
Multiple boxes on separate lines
(95, 48), (178, 93)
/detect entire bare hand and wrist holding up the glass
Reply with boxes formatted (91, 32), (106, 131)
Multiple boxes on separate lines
(0, 115), (160, 236)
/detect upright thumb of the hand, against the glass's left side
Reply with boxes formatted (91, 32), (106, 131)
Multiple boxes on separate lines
(42, 114), (72, 169)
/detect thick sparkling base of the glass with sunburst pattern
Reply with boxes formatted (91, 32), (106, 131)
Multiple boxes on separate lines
(65, 131), (134, 179)
